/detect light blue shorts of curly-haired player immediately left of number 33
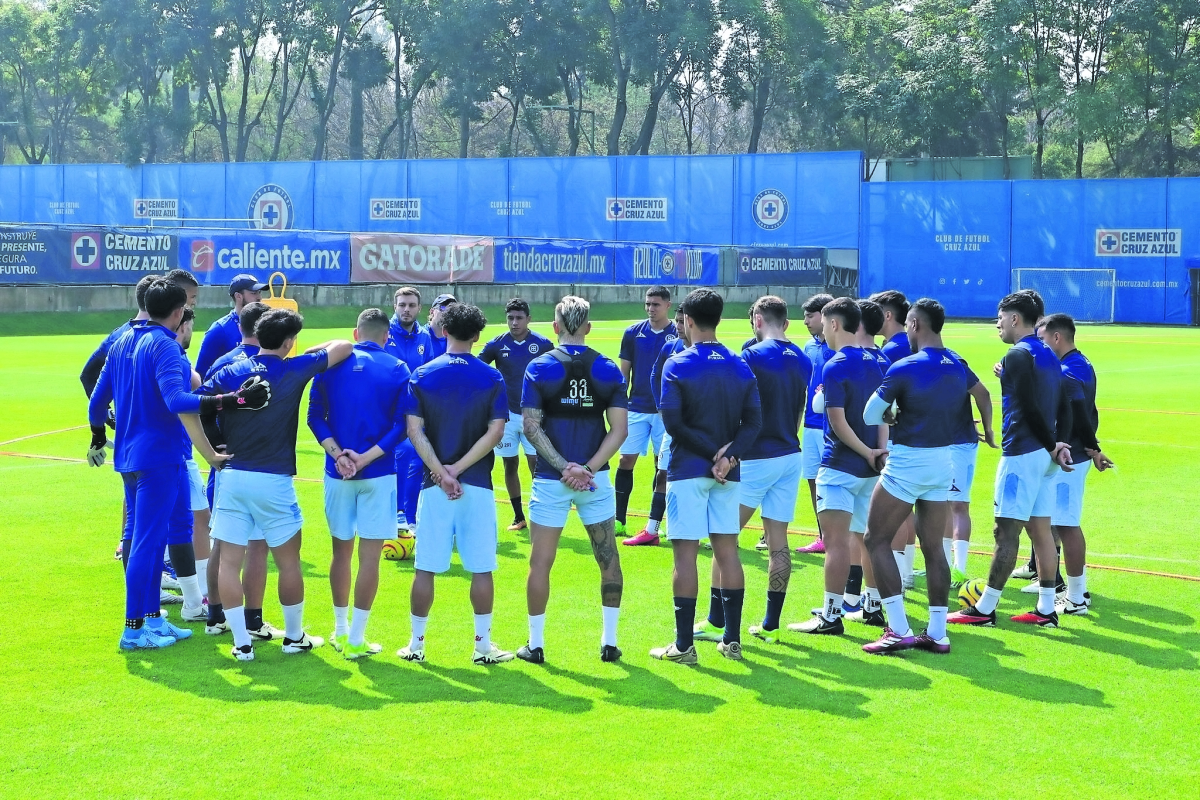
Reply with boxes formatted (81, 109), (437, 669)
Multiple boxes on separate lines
(416, 483), (498, 572)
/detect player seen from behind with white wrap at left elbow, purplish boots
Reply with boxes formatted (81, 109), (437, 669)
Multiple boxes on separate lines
(863, 297), (978, 654)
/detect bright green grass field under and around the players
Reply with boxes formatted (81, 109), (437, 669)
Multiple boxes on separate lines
(0, 314), (1200, 798)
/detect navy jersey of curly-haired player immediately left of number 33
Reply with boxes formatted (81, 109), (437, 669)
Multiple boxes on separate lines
(404, 353), (509, 489)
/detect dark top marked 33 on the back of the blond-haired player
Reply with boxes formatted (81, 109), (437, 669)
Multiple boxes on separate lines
(521, 344), (628, 481)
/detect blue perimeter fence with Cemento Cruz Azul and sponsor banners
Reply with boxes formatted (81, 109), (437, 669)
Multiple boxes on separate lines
(0, 152), (1200, 324)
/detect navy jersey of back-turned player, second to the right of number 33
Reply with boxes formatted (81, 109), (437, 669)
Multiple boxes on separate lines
(742, 339), (812, 461)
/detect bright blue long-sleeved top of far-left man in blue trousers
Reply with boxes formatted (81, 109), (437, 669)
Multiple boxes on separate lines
(88, 321), (200, 473)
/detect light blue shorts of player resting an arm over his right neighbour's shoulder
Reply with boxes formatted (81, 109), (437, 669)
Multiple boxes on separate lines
(212, 469), (304, 547)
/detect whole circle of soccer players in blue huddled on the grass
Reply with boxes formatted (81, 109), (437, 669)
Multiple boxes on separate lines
(87, 270), (1112, 664)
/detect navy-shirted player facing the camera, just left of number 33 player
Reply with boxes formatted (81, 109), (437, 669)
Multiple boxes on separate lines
(479, 297), (554, 530)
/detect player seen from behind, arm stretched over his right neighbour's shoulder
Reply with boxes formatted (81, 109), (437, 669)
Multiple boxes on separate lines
(202, 308), (353, 661)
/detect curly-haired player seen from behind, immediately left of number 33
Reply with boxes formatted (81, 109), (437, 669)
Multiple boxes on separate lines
(396, 302), (514, 664)
